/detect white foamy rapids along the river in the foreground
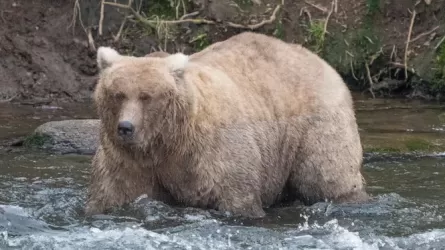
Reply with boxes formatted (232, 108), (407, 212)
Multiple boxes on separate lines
(0, 216), (445, 250)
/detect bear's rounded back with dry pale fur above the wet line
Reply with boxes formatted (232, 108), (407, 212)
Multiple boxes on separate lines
(186, 32), (352, 119)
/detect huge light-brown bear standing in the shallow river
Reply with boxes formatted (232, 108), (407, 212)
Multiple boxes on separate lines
(86, 32), (369, 217)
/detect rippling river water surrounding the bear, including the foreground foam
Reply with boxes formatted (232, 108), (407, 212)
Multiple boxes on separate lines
(0, 95), (445, 249)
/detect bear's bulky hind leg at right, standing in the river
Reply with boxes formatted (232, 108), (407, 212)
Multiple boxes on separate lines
(289, 112), (369, 205)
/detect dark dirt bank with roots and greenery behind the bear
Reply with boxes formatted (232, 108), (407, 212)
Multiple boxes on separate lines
(0, 0), (445, 104)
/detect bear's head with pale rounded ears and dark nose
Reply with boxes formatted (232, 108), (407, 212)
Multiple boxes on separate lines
(94, 47), (191, 148)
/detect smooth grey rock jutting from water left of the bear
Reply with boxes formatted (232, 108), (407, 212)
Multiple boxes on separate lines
(30, 119), (99, 155)
